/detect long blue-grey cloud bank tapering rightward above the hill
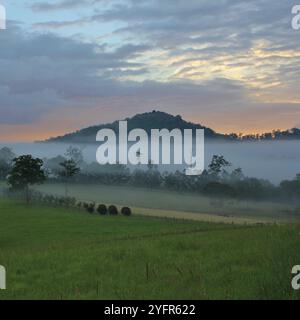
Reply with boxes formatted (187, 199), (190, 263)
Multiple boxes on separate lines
(0, 23), (258, 124)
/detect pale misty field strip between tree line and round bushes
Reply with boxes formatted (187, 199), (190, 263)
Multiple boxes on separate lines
(37, 184), (300, 223)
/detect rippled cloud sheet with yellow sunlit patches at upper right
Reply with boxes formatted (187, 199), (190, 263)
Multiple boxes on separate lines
(29, 0), (300, 94)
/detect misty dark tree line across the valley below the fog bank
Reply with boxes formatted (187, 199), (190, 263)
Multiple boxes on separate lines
(0, 147), (300, 201)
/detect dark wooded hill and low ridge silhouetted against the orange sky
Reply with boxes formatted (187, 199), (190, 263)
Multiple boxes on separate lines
(44, 110), (300, 143)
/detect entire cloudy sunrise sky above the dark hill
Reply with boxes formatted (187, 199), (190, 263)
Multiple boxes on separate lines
(0, 0), (300, 141)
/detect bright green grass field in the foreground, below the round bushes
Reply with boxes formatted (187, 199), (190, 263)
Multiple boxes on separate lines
(0, 199), (300, 299)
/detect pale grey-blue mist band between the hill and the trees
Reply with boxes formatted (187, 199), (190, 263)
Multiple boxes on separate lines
(0, 141), (300, 184)
